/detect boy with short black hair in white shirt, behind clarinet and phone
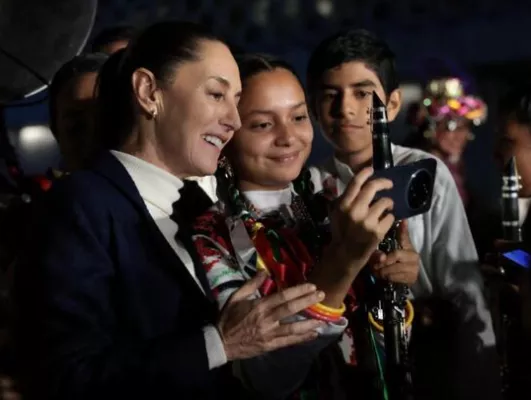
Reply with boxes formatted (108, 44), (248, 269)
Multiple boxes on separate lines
(307, 30), (497, 398)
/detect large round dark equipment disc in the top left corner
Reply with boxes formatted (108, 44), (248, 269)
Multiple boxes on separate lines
(0, 0), (98, 105)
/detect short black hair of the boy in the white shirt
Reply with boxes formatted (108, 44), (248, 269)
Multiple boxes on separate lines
(307, 29), (399, 97)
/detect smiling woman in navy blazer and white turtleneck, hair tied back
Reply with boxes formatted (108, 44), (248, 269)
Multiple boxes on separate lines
(15, 22), (322, 400)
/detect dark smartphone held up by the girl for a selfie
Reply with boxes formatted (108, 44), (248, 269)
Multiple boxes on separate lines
(371, 158), (437, 220)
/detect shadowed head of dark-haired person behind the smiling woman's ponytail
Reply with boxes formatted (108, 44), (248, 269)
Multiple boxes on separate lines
(49, 53), (108, 171)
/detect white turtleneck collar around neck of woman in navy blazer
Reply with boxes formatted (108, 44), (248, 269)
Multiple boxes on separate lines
(111, 150), (184, 215)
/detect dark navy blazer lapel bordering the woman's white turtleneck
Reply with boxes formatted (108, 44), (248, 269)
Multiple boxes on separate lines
(92, 153), (212, 303)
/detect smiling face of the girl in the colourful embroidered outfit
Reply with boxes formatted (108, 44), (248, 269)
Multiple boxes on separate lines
(228, 68), (313, 190)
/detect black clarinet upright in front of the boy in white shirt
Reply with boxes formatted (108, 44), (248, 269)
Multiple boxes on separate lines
(371, 92), (413, 400)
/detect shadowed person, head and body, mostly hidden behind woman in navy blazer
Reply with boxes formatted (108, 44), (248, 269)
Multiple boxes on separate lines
(0, 54), (107, 400)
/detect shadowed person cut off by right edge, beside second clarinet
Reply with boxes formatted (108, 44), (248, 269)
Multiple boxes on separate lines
(482, 86), (531, 399)
